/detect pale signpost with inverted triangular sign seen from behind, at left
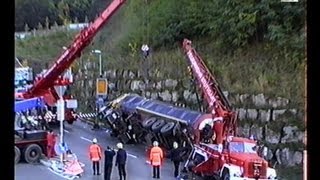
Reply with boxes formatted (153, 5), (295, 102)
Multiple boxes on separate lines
(54, 86), (67, 162)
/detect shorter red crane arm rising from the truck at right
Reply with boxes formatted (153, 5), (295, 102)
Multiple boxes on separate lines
(183, 39), (236, 144)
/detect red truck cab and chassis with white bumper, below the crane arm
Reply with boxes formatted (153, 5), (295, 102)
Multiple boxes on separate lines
(185, 137), (277, 180)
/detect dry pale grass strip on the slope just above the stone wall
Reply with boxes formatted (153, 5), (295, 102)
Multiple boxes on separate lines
(15, 31), (304, 108)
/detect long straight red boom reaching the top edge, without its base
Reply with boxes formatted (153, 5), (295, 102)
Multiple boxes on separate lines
(26, 0), (125, 97)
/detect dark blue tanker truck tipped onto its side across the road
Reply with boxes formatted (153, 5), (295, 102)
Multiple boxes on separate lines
(99, 94), (208, 150)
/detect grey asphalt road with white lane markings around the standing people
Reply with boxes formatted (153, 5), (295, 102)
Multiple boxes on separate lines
(15, 121), (184, 180)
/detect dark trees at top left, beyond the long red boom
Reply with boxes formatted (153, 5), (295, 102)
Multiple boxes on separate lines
(15, 0), (100, 31)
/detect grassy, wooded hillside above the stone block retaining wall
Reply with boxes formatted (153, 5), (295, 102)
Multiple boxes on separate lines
(15, 0), (306, 179)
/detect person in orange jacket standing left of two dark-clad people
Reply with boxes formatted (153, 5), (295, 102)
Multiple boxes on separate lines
(89, 138), (102, 175)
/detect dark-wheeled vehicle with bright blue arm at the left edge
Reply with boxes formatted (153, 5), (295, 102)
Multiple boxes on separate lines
(14, 97), (47, 163)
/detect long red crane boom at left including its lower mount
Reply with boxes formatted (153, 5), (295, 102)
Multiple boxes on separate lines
(17, 0), (125, 124)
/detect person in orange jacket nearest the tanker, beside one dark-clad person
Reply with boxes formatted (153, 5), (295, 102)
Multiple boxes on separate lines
(150, 141), (163, 179)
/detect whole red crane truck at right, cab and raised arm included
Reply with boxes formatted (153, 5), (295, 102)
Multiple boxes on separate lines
(183, 39), (276, 180)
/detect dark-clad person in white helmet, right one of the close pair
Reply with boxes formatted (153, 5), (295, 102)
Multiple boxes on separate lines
(116, 143), (127, 180)
